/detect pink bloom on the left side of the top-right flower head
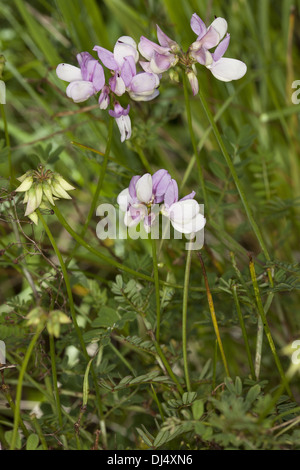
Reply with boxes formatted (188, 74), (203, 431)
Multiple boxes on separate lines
(138, 26), (180, 74)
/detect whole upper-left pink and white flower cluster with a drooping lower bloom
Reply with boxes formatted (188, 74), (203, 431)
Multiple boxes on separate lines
(56, 36), (159, 142)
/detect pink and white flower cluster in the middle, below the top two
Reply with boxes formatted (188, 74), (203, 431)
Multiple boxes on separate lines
(117, 169), (206, 234)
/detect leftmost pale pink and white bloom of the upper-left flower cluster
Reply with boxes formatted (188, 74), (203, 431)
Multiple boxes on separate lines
(56, 52), (105, 103)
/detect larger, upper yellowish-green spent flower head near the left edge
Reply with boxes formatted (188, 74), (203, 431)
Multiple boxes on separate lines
(15, 165), (75, 225)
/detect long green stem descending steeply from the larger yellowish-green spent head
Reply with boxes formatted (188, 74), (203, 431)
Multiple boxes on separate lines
(37, 209), (107, 447)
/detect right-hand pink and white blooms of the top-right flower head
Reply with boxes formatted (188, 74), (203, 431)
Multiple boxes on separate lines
(188, 13), (247, 82)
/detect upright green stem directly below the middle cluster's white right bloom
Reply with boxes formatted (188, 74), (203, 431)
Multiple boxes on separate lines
(182, 246), (192, 392)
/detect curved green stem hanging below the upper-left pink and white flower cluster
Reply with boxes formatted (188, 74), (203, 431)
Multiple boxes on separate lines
(66, 116), (114, 266)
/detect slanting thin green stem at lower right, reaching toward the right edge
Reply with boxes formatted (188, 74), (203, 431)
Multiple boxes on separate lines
(249, 258), (293, 398)
